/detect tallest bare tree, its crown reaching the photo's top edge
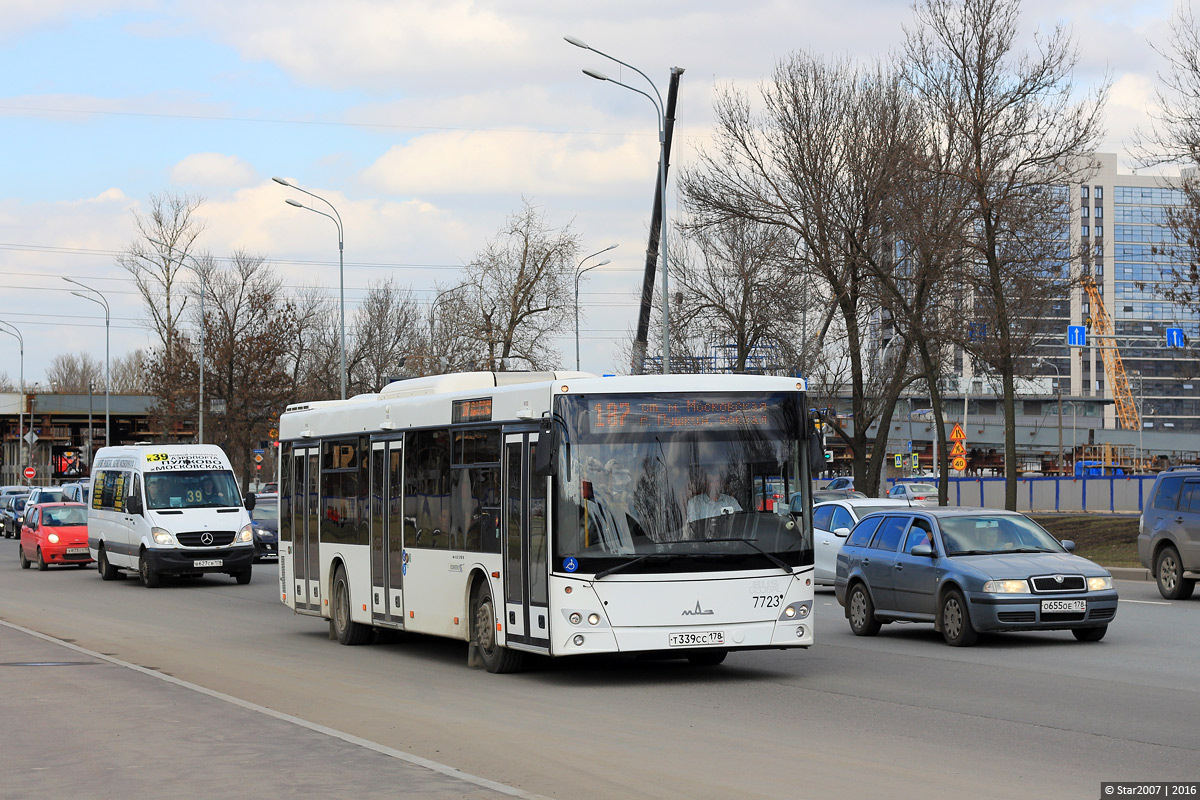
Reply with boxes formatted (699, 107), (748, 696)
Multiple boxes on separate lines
(905, 0), (1108, 509)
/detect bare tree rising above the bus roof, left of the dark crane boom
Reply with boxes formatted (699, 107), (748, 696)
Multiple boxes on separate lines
(455, 199), (578, 369)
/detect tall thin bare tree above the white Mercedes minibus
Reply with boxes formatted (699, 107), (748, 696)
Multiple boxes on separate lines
(116, 194), (204, 435)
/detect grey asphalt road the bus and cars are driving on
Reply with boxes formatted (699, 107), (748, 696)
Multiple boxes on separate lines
(0, 540), (1200, 800)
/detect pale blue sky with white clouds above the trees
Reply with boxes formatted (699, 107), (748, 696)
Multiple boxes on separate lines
(0, 0), (1176, 385)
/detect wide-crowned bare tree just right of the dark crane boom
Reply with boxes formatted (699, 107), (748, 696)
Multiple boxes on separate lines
(682, 53), (916, 486)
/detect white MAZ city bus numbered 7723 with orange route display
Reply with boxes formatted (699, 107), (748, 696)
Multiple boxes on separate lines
(280, 372), (823, 672)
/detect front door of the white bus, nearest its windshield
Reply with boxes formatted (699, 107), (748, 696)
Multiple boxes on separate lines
(502, 429), (550, 651)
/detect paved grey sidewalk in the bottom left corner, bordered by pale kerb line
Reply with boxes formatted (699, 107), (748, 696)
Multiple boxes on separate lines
(0, 622), (532, 800)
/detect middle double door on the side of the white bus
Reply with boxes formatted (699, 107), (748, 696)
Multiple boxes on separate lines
(371, 439), (404, 626)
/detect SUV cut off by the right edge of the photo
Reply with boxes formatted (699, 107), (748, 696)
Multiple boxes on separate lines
(1138, 467), (1200, 600)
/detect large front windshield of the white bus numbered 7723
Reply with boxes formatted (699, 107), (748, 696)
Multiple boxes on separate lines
(554, 393), (812, 572)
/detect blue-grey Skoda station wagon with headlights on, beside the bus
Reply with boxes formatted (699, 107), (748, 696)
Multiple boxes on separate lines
(834, 506), (1117, 646)
